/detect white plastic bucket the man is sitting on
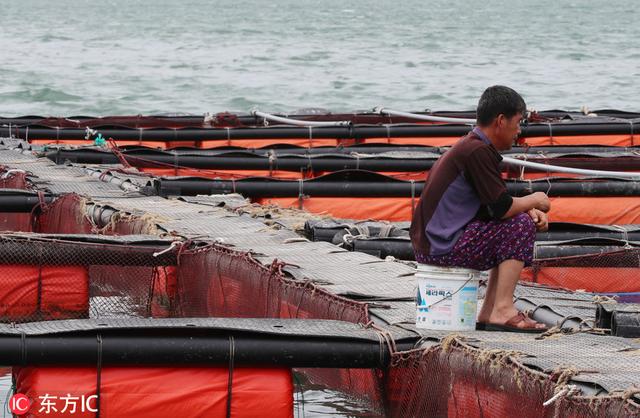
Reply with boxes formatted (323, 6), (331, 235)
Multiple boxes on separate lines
(415, 264), (480, 331)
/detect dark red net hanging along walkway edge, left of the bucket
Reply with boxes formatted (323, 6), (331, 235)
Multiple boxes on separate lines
(178, 245), (367, 323)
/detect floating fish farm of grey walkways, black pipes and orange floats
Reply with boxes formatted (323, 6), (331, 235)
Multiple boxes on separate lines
(0, 108), (640, 418)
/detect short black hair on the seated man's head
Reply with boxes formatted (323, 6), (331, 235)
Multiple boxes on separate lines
(476, 86), (527, 126)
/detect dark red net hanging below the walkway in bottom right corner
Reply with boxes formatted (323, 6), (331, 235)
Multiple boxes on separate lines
(385, 337), (640, 418)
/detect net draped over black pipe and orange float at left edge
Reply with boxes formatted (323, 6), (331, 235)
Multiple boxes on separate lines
(0, 234), (176, 322)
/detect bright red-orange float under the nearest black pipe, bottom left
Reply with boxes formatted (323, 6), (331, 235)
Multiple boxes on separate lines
(13, 367), (293, 418)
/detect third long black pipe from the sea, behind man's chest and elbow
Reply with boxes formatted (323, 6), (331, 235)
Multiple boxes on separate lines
(154, 172), (640, 198)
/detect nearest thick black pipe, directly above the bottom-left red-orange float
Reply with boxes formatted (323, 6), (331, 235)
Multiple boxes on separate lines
(0, 330), (398, 368)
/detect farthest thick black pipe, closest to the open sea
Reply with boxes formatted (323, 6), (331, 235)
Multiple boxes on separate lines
(8, 122), (640, 141)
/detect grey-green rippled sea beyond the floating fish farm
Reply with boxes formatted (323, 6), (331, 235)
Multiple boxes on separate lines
(0, 0), (640, 116)
